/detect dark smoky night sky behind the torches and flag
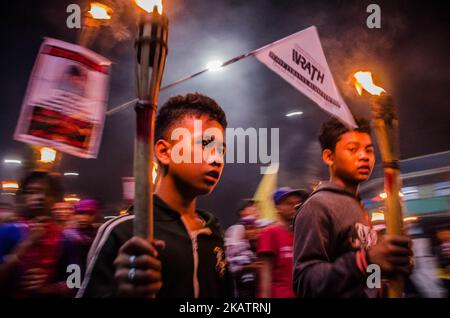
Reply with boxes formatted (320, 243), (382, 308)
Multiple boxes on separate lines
(0, 0), (450, 227)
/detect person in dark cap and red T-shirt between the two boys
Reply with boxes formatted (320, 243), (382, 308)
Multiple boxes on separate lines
(257, 187), (308, 298)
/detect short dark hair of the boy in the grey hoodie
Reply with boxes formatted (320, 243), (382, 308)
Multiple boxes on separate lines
(319, 117), (371, 151)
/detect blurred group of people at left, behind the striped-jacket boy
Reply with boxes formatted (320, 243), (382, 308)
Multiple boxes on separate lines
(0, 171), (101, 298)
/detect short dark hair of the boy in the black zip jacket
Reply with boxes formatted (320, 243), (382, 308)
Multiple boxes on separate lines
(155, 93), (227, 142)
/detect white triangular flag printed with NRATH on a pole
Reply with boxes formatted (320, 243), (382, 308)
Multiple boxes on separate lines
(255, 26), (357, 128)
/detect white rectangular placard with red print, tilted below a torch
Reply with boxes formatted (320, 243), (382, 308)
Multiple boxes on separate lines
(14, 38), (111, 158)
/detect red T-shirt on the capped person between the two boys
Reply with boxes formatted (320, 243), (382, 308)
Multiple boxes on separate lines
(258, 224), (295, 298)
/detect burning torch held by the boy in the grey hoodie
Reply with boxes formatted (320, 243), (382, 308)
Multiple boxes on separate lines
(354, 72), (404, 298)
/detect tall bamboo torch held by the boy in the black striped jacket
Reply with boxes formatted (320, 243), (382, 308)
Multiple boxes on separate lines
(134, 0), (169, 240)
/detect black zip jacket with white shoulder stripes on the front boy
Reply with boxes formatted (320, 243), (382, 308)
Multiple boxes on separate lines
(77, 195), (231, 298)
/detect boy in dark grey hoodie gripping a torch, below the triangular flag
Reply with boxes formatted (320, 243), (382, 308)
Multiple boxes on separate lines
(293, 119), (412, 297)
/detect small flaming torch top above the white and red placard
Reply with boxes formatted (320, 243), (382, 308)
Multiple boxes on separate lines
(78, 2), (112, 47)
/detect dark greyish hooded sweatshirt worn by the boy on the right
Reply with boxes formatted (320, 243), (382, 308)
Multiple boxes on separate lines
(293, 182), (379, 298)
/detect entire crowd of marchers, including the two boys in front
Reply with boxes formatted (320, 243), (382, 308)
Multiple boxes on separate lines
(0, 93), (449, 298)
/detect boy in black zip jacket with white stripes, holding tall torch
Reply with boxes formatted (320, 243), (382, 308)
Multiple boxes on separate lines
(78, 93), (229, 298)
